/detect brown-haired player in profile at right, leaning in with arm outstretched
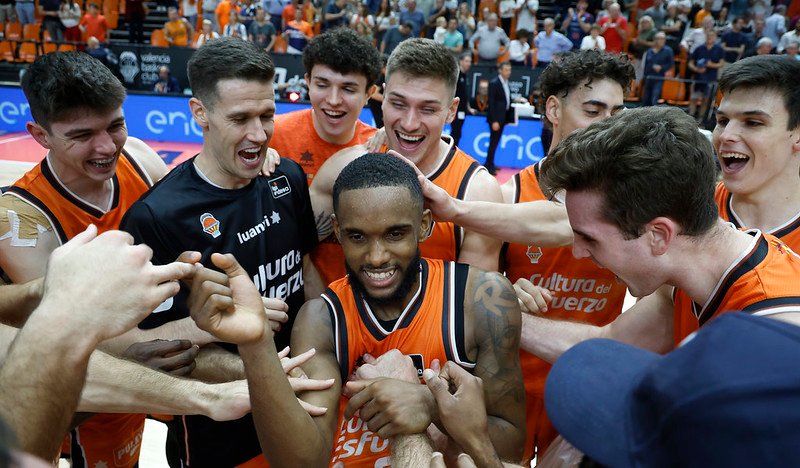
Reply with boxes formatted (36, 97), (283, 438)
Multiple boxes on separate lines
(523, 107), (800, 361)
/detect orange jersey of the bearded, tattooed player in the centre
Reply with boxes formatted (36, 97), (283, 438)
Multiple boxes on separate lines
(322, 259), (475, 468)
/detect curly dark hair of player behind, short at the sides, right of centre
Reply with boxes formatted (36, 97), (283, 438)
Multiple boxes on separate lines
(539, 49), (635, 114)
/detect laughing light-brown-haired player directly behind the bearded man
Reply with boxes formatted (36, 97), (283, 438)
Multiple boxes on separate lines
(311, 39), (501, 271)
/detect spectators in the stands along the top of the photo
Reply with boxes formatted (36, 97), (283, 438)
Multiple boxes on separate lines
(0, 0), (800, 114)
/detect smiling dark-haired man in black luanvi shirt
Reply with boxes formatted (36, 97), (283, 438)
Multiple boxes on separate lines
(122, 38), (321, 466)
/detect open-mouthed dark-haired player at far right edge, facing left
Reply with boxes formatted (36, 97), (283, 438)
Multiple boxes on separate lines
(675, 55), (800, 340)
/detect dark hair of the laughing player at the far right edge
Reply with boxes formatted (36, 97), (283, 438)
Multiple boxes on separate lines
(719, 55), (800, 130)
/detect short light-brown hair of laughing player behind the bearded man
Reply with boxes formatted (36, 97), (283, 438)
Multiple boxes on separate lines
(386, 38), (458, 99)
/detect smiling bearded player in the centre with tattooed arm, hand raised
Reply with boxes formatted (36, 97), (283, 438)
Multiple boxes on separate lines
(186, 154), (524, 466)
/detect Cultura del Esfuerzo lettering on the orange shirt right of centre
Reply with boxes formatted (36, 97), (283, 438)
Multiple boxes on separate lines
(530, 273), (612, 313)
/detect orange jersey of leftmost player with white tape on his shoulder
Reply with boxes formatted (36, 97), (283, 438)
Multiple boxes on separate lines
(7, 150), (152, 467)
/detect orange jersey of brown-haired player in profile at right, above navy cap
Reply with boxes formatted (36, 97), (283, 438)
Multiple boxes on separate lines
(673, 229), (800, 345)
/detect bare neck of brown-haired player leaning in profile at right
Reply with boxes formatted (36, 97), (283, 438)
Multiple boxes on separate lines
(668, 220), (757, 305)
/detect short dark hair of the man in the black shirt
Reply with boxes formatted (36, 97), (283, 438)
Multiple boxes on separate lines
(187, 37), (275, 108)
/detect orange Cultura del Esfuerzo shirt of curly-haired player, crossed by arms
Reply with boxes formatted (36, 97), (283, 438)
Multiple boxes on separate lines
(503, 163), (626, 459)
